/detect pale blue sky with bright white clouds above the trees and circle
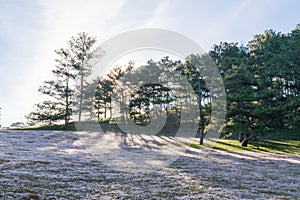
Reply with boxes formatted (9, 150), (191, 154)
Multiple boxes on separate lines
(0, 0), (300, 126)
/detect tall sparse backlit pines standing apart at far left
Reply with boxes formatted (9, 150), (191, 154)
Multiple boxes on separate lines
(26, 32), (99, 124)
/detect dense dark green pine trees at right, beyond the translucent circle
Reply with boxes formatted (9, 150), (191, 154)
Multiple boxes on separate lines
(210, 25), (300, 146)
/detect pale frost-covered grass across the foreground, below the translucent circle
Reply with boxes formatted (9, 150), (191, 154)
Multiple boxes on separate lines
(0, 131), (300, 199)
